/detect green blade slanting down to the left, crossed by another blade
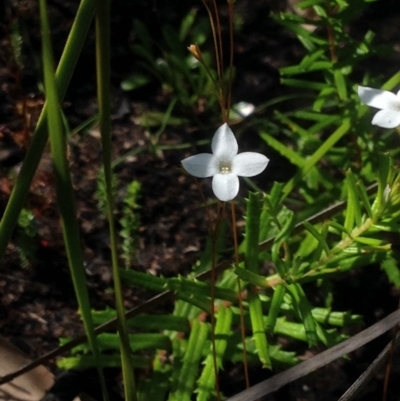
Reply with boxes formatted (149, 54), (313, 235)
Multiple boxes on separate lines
(0, 0), (95, 259)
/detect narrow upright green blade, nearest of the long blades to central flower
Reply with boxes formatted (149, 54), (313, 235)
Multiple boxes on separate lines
(96, 0), (137, 401)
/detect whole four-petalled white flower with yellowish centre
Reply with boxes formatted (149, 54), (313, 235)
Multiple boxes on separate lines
(182, 123), (269, 201)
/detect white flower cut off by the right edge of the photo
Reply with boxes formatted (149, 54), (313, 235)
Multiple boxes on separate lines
(358, 86), (400, 128)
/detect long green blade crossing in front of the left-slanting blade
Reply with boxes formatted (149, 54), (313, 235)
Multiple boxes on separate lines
(40, 0), (108, 400)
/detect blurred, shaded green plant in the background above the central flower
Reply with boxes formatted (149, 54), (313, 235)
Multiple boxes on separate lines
(121, 9), (216, 112)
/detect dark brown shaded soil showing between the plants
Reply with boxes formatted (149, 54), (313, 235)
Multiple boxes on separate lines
(0, 0), (400, 401)
